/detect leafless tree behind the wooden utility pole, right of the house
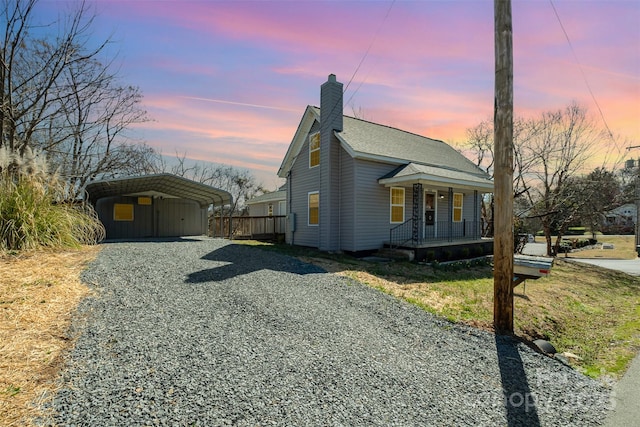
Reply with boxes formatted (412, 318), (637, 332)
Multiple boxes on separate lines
(465, 103), (603, 255)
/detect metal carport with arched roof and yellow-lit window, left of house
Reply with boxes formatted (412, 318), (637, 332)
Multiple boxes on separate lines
(85, 173), (233, 239)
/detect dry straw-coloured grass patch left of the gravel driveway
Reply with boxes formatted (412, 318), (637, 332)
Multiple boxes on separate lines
(0, 246), (99, 426)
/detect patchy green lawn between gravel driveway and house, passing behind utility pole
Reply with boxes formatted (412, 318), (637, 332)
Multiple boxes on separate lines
(236, 236), (640, 378)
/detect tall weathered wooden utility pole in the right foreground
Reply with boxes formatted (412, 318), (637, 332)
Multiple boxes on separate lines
(493, 0), (513, 334)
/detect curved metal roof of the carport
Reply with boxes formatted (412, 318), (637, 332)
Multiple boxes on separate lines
(85, 173), (233, 208)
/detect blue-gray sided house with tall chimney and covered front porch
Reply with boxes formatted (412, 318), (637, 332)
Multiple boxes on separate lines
(278, 74), (493, 258)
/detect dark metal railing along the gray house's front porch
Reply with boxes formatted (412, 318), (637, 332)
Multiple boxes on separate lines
(389, 219), (482, 247)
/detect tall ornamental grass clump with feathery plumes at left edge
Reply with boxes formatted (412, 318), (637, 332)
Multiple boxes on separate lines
(0, 148), (105, 252)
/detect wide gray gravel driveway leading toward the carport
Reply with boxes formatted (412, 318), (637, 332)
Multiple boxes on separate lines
(49, 239), (610, 426)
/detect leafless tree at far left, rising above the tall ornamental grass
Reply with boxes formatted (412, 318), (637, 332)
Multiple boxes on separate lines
(0, 0), (106, 154)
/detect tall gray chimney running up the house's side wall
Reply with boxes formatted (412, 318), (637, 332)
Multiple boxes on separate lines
(319, 74), (343, 252)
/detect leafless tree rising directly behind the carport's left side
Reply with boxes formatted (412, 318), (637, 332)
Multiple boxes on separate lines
(44, 54), (152, 196)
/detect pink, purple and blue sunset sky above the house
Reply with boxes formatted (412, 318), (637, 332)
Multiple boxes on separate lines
(44, 0), (640, 189)
